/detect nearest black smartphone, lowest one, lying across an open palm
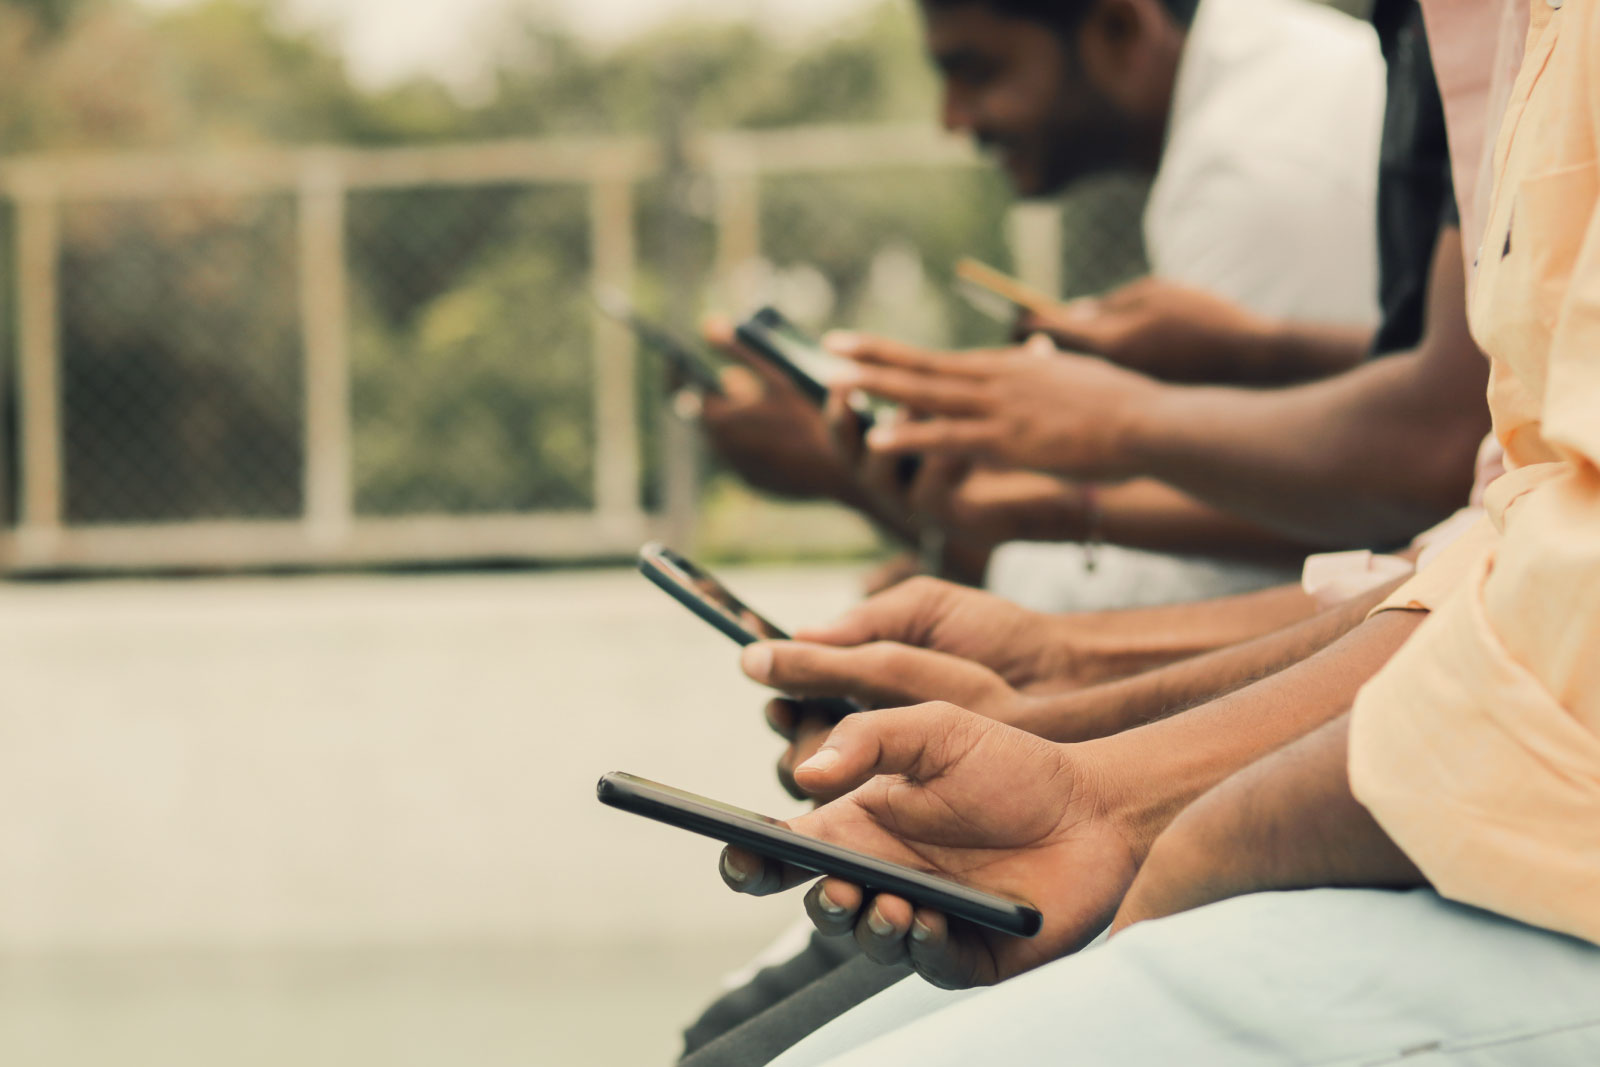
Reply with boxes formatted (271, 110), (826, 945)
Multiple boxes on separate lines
(595, 774), (1043, 937)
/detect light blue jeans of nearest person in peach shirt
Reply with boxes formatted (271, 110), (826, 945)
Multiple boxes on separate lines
(761, 889), (1600, 1067)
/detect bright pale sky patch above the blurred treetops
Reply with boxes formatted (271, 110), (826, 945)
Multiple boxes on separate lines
(139, 0), (870, 88)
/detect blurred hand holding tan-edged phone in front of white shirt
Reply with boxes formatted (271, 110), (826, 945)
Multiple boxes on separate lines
(1018, 278), (1272, 381)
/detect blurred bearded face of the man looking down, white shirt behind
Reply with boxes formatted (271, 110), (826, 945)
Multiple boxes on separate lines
(923, 3), (1128, 197)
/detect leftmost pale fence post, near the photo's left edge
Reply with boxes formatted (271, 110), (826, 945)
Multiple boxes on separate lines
(16, 178), (64, 558)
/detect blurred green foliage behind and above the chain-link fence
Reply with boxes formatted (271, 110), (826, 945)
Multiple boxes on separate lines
(0, 0), (1036, 522)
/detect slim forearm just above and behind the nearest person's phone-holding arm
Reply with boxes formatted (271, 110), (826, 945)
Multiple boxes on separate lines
(1029, 582), (1400, 741)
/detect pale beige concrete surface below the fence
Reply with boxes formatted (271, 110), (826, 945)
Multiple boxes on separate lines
(0, 566), (876, 1067)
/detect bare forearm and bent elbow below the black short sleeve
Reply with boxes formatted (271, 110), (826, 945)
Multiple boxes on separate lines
(1125, 232), (1488, 547)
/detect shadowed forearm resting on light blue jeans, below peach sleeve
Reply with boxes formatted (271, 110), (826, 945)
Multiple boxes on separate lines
(1117, 713), (1426, 928)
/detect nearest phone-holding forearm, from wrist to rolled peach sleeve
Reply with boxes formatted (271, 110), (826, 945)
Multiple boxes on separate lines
(1085, 611), (1424, 843)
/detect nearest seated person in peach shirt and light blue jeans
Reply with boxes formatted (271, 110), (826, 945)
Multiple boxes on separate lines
(707, 3), (1600, 1065)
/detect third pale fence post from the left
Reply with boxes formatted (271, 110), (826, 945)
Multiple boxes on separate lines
(589, 167), (643, 522)
